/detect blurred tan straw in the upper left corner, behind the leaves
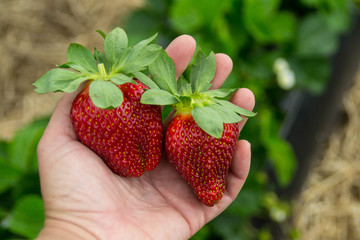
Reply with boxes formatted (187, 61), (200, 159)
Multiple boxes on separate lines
(0, 0), (143, 139)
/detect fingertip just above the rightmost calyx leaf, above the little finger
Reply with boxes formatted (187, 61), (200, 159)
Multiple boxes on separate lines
(230, 88), (255, 131)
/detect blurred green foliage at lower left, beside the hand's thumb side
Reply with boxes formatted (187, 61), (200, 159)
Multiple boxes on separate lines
(0, 118), (48, 239)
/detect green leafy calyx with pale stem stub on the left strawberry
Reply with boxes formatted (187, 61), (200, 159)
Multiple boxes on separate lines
(34, 27), (161, 109)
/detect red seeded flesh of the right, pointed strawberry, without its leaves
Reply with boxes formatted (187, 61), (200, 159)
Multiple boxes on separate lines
(165, 114), (239, 206)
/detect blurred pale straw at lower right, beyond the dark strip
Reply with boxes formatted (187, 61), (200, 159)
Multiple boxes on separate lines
(294, 68), (360, 240)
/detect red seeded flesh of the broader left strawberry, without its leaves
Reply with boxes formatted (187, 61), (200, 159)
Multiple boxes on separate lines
(71, 81), (163, 177)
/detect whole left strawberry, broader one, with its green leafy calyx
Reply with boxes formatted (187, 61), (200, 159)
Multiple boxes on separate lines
(34, 28), (163, 177)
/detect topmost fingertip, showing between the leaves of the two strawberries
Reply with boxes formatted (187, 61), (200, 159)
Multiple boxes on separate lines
(166, 35), (196, 79)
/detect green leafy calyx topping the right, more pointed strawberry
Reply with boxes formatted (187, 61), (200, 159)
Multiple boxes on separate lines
(141, 50), (256, 138)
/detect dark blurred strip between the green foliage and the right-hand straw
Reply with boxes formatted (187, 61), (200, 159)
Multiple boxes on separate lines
(281, 18), (360, 197)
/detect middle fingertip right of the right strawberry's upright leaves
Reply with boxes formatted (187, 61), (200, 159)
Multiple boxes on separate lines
(211, 53), (233, 89)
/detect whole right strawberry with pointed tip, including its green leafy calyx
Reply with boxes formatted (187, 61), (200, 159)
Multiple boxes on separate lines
(141, 51), (255, 206)
